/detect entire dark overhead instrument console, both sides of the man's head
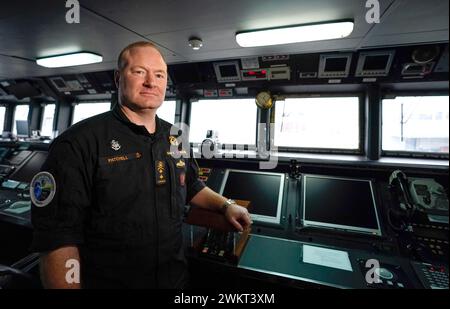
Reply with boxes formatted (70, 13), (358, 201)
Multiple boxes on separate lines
(0, 43), (449, 99)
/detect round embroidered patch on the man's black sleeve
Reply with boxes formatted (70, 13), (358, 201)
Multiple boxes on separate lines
(30, 172), (56, 207)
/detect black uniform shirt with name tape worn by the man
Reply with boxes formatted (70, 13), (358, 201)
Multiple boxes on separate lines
(28, 105), (204, 288)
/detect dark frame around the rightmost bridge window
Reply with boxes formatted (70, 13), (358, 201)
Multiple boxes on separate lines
(379, 90), (449, 160)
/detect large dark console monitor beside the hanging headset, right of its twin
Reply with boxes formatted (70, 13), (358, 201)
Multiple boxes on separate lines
(302, 175), (381, 236)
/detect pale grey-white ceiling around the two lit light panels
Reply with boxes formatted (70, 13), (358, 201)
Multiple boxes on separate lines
(0, 0), (449, 79)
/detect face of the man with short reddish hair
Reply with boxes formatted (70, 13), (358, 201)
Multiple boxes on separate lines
(116, 47), (167, 111)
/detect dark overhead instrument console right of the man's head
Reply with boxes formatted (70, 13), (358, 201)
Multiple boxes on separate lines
(161, 44), (448, 98)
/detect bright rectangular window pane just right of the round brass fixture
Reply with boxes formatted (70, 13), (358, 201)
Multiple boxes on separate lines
(274, 97), (360, 150)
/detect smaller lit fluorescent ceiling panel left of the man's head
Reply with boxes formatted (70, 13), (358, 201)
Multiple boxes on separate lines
(36, 52), (103, 68)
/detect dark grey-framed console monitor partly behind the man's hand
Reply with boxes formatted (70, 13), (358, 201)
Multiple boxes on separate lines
(220, 169), (285, 224)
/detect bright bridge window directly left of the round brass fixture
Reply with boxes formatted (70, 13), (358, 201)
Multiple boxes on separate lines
(189, 99), (257, 145)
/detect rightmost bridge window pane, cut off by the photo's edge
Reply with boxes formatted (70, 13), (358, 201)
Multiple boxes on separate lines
(382, 96), (449, 154)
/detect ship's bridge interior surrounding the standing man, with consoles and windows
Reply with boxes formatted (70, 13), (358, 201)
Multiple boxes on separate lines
(0, 0), (449, 289)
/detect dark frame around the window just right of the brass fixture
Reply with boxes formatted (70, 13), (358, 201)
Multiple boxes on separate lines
(271, 92), (367, 155)
